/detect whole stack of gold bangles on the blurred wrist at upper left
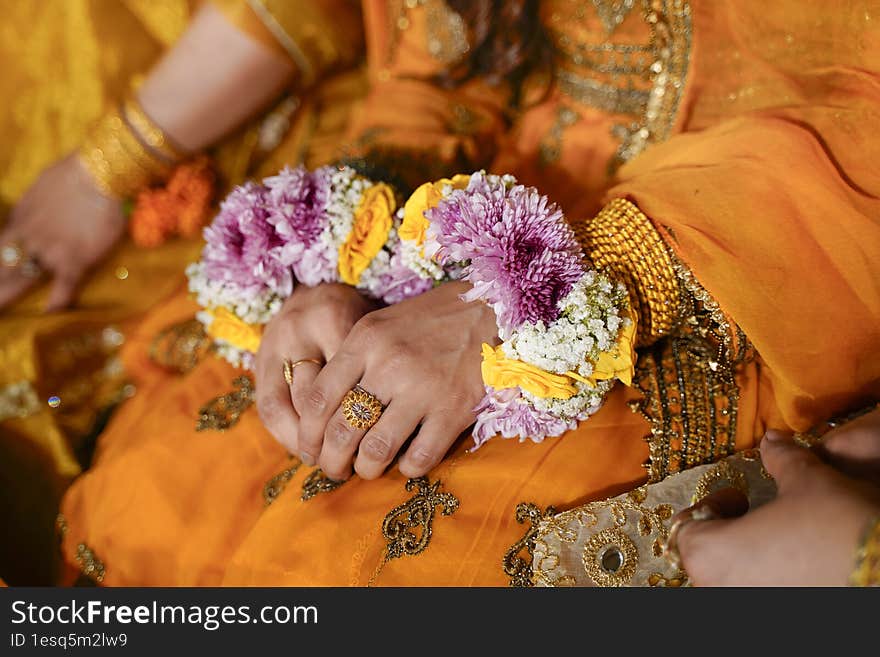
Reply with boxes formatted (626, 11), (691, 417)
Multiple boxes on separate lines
(79, 95), (184, 199)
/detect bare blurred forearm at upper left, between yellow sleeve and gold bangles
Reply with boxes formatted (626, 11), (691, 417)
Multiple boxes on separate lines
(137, 4), (296, 151)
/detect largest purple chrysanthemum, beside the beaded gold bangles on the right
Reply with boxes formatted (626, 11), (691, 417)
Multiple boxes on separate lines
(427, 174), (583, 334)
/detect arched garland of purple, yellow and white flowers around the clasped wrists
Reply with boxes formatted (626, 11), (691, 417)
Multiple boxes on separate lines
(187, 167), (636, 447)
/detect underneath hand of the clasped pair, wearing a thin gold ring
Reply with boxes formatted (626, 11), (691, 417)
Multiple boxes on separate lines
(254, 284), (375, 454)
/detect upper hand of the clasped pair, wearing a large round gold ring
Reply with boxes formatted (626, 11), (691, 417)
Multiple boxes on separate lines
(294, 283), (497, 479)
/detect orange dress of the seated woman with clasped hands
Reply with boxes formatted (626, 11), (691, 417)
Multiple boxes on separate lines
(63, 0), (880, 586)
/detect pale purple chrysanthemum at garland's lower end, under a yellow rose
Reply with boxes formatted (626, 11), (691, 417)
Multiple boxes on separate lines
(472, 386), (577, 449)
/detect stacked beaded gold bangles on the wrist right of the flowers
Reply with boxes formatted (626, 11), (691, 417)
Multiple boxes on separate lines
(573, 198), (681, 345)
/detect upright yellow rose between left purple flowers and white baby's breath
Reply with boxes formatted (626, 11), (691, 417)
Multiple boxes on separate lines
(339, 183), (396, 285)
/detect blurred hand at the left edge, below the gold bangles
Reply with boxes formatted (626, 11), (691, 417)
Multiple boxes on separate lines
(0, 155), (125, 310)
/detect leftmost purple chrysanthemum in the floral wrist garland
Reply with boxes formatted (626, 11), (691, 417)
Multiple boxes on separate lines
(202, 182), (293, 296)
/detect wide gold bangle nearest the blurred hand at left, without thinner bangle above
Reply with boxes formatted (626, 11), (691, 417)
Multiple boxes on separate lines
(80, 107), (171, 199)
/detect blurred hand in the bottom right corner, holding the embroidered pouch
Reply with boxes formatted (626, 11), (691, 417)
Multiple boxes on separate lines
(678, 427), (880, 586)
